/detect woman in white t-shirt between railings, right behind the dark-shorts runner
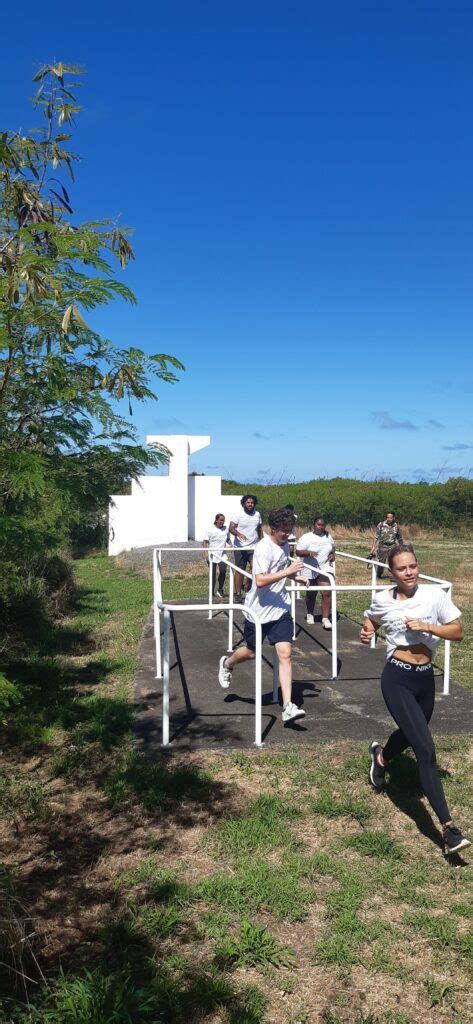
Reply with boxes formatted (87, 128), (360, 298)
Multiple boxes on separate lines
(296, 515), (335, 630)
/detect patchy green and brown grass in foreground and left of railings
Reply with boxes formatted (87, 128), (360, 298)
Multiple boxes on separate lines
(0, 556), (472, 1024)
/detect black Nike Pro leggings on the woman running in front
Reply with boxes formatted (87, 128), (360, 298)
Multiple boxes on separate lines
(381, 657), (450, 824)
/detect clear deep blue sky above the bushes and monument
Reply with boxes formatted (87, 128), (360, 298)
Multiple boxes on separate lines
(0, 0), (473, 481)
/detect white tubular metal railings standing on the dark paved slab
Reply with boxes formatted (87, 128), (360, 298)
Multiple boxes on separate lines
(153, 545), (453, 746)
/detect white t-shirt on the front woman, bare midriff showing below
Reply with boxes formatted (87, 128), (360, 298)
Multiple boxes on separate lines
(364, 584), (462, 657)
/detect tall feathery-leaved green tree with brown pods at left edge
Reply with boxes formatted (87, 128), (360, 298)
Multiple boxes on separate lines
(0, 63), (183, 634)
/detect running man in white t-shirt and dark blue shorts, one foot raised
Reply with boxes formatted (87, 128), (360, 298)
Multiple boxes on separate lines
(218, 509), (305, 725)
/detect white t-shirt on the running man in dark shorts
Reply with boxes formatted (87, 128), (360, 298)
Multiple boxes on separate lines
(245, 534), (291, 623)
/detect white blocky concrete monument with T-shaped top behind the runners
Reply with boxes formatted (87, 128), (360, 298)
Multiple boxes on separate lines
(109, 434), (241, 555)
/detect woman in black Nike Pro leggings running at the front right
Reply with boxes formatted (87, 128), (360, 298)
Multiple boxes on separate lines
(359, 544), (470, 856)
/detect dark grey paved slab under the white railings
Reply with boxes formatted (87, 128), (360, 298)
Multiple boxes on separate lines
(135, 601), (473, 752)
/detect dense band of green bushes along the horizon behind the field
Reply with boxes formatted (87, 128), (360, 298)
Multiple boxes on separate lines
(222, 476), (473, 529)
